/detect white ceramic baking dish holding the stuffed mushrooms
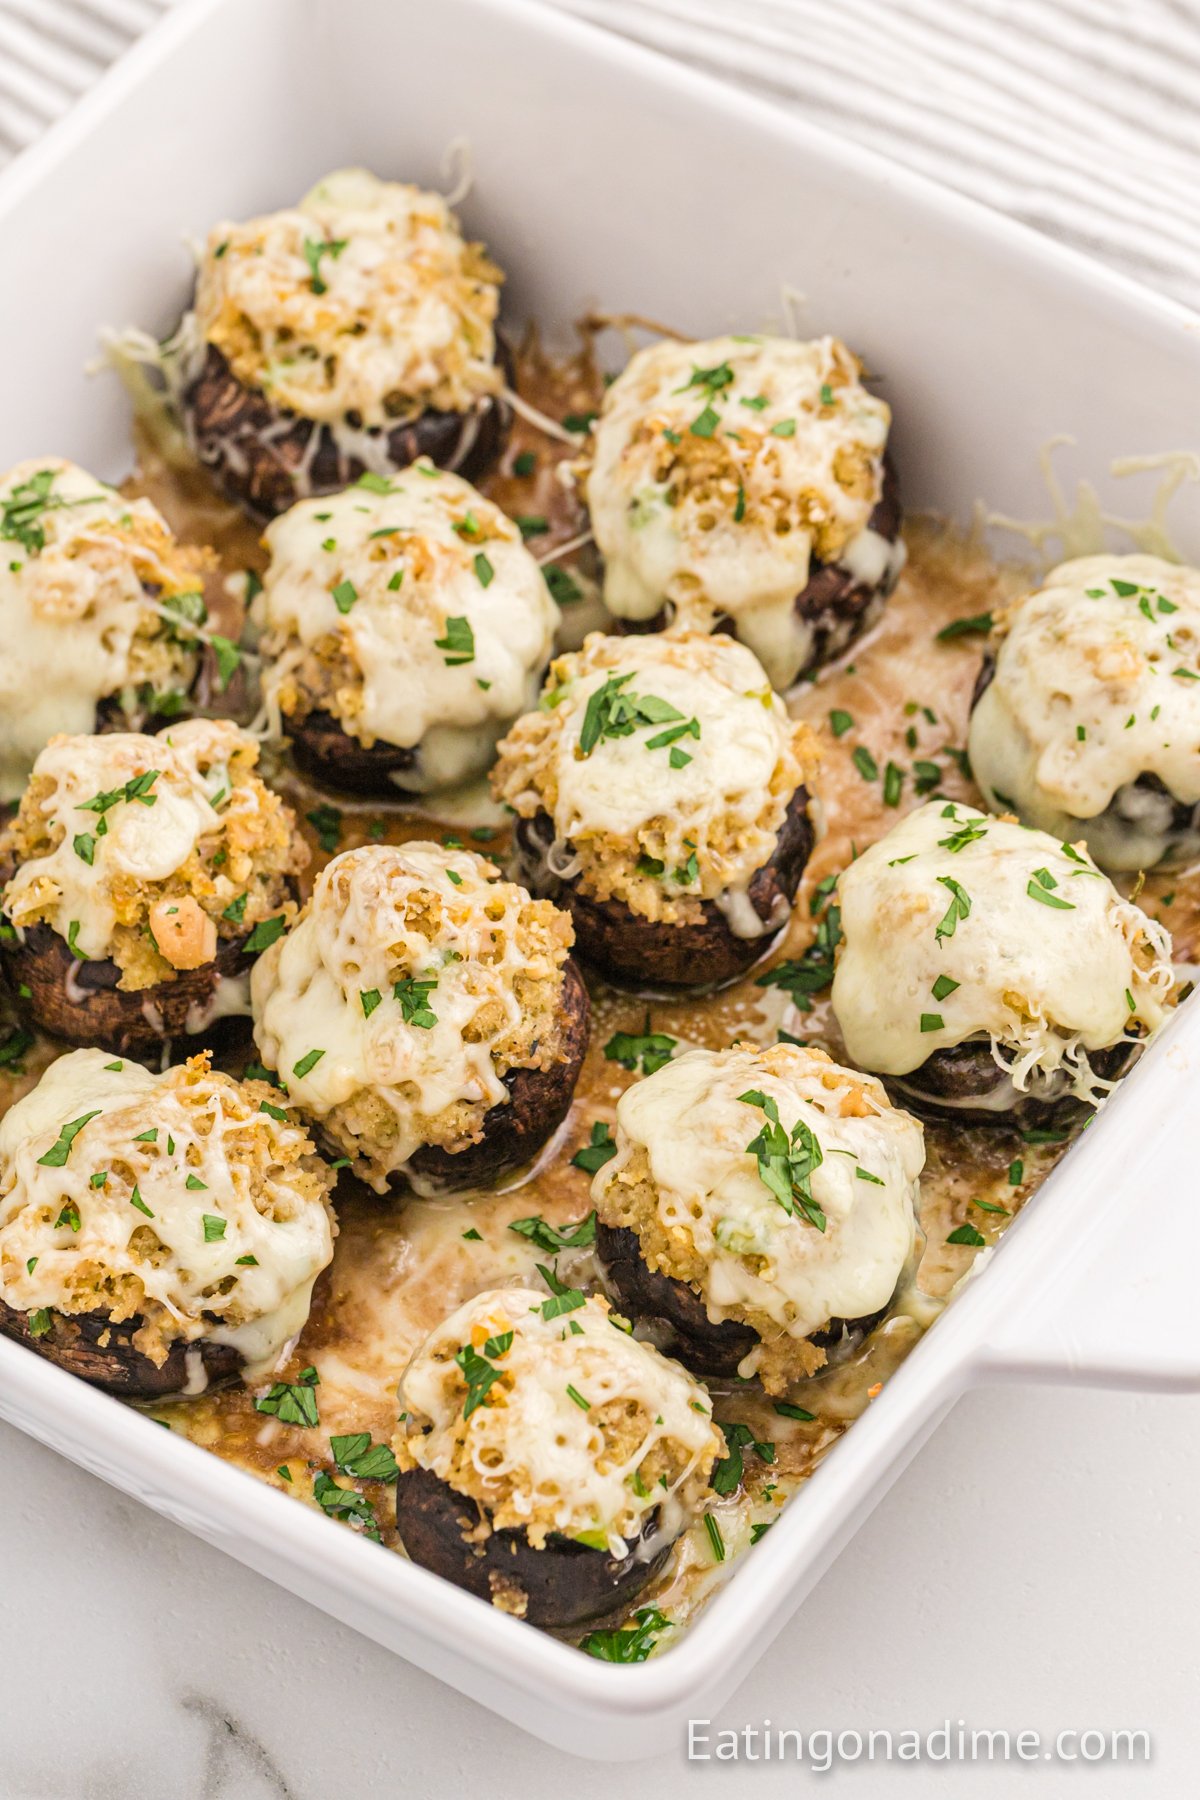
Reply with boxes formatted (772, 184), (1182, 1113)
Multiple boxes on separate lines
(0, 0), (1200, 1757)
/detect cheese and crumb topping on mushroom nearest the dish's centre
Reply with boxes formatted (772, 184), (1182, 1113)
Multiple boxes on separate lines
(493, 634), (815, 936)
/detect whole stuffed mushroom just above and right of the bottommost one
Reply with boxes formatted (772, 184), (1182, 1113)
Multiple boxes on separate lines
(592, 1044), (925, 1393)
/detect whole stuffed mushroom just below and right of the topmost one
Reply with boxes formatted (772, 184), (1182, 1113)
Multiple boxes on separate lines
(254, 461), (558, 796)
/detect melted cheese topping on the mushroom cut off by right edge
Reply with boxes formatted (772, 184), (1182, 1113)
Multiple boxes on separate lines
(968, 556), (1200, 869)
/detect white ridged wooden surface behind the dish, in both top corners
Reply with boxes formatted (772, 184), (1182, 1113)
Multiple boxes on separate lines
(0, 0), (1200, 308)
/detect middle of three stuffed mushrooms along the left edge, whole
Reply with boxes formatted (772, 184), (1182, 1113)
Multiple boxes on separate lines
(0, 718), (308, 1055)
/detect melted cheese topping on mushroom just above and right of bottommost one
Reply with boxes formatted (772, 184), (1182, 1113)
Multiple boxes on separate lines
(592, 1044), (925, 1375)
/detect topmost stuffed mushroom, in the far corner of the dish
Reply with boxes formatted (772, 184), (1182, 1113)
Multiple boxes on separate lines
(164, 169), (511, 517)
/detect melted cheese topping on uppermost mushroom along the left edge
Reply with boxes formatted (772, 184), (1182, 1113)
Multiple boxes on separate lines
(0, 457), (200, 799)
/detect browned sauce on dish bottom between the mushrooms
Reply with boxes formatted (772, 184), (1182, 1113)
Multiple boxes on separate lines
(0, 344), (1200, 1647)
